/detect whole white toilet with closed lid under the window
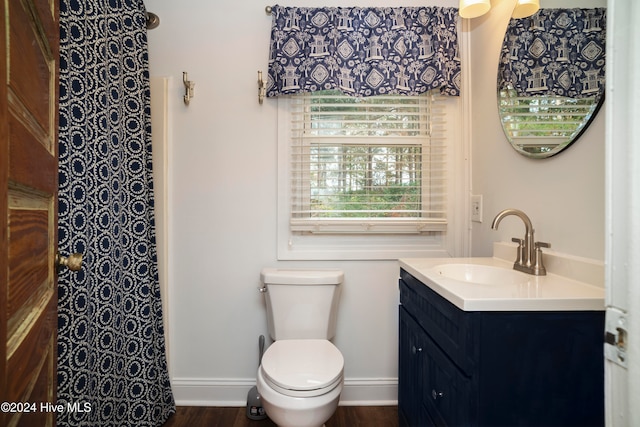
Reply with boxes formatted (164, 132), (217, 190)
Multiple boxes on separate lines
(257, 268), (344, 427)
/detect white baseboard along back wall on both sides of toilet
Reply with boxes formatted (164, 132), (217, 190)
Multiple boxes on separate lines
(171, 378), (398, 406)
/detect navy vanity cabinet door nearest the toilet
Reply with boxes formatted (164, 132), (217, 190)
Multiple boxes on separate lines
(398, 307), (433, 427)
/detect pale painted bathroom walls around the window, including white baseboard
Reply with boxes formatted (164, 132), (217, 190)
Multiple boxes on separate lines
(145, 0), (632, 422)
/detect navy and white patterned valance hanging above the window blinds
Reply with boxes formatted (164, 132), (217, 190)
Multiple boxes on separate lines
(267, 6), (460, 96)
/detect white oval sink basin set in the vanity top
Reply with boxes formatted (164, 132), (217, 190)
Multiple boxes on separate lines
(433, 264), (529, 285)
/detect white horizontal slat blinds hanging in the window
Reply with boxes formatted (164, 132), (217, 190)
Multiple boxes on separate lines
(290, 91), (447, 234)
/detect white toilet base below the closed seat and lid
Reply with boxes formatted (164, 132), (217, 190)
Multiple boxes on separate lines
(257, 370), (343, 427)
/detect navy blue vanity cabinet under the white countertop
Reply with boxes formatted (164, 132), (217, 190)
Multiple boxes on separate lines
(398, 270), (604, 427)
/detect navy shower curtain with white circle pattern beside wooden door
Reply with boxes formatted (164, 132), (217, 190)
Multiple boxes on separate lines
(58, 0), (175, 427)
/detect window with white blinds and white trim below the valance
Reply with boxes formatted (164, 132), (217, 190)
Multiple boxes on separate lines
(279, 91), (458, 259)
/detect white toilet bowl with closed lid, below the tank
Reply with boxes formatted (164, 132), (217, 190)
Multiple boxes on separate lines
(257, 339), (344, 427)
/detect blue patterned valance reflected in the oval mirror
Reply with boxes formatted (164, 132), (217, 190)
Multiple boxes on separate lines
(498, 8), (606, 98)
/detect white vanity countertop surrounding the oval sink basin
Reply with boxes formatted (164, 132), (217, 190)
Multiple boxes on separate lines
(399, 257), (605, 311)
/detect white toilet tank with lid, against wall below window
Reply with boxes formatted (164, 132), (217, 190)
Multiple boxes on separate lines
(260, 268), (344, 340)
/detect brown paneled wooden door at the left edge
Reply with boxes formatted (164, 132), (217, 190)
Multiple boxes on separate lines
(0, 0), (59, 427)
